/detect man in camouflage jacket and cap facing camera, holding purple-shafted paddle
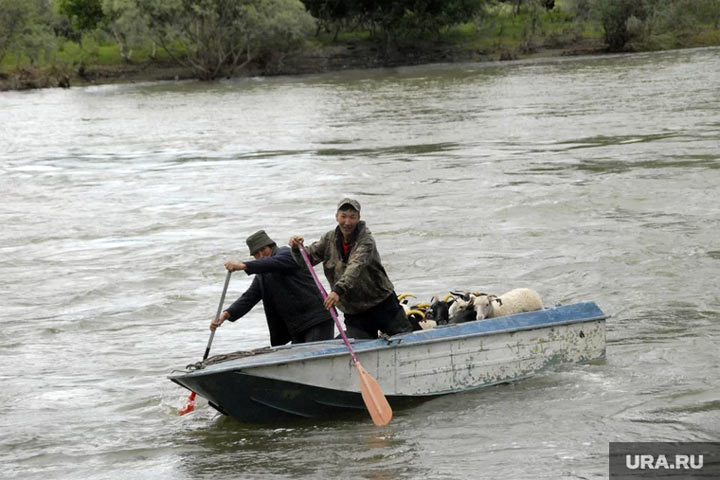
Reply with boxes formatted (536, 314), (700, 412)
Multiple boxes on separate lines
(290, 198), (412, 338)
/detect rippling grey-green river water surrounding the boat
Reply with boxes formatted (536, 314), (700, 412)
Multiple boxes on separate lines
(0, 48), (720, 480)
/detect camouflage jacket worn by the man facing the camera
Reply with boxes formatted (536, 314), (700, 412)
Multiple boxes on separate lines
(293, 221), (395, 314)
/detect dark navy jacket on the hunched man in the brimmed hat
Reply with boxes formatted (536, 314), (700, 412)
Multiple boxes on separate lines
(227, 246), (332, 346)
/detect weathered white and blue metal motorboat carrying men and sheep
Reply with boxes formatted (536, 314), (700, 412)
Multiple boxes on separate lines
(168, 302), (607, 423)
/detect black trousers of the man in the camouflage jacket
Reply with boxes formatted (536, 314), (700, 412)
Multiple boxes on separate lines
(345, 292), (412, 339)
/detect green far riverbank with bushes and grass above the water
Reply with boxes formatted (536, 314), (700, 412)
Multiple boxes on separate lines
(5, 0), (720, 90)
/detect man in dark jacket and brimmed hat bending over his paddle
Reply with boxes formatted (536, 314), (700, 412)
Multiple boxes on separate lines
(210, 230), (335, 346)
